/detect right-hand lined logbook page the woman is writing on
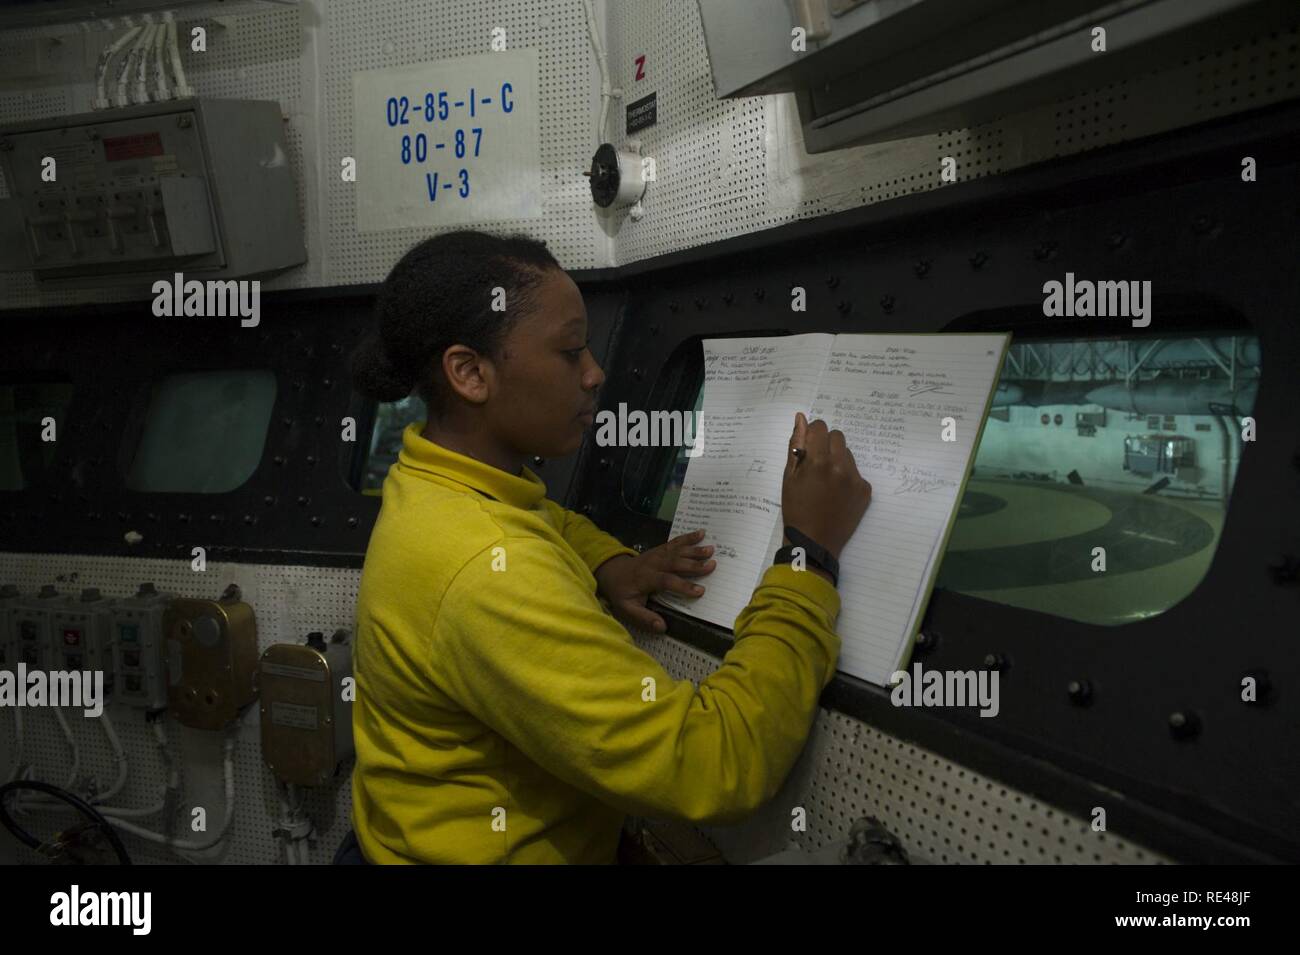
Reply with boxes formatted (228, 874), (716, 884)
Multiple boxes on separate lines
(811, 334), (1008, 685)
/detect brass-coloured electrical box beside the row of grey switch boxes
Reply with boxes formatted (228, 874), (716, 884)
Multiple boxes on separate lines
(163, 596), (257, 729)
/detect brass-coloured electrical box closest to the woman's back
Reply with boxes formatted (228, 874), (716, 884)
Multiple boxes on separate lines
(257, 630), (352, 786)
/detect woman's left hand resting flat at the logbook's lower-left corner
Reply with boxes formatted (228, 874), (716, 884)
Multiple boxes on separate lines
(594, 530), (718, 633)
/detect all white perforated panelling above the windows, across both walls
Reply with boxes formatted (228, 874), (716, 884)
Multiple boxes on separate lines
(0, 0), (1300, 307)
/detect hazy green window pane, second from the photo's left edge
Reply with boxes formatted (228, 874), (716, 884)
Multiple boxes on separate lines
(126, 370), (276, 494)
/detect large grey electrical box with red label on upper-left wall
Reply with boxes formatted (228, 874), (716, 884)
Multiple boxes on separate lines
(0, 99), (307, 291)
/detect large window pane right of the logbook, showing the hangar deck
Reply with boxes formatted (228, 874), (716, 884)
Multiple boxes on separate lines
(935, 335), (1260, 625)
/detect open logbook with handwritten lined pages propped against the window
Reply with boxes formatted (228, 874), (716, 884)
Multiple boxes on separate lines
(657, 333), (1010, 686)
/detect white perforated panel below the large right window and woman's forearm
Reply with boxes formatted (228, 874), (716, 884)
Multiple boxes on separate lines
(634, 633), (1171, 864)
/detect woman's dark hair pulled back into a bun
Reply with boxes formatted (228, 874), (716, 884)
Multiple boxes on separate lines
(352, 229), (560, 414)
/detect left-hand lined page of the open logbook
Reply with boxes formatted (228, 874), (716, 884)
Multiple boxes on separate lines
(655, 334), (835, 628)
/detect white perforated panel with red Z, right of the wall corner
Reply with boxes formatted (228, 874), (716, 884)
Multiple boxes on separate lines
(610, 0), (1300, 264)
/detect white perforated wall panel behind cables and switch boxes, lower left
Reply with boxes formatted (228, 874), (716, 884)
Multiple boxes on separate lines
(0, 554), (360, 864)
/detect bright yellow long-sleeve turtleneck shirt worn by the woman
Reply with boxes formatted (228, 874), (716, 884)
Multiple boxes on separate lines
(352, 424), (840, 863)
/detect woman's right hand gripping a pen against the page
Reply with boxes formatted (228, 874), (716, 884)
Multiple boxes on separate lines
(781, 413), (871, 560)
